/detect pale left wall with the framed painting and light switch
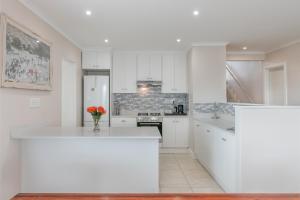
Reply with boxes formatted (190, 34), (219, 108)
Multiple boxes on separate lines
(0, 0), (81, 200)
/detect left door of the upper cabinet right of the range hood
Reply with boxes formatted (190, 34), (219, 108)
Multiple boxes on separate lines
(162, 54), (175, 93)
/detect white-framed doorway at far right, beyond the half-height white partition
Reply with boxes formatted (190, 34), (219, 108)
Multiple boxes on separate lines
(264, 63), (288, 106)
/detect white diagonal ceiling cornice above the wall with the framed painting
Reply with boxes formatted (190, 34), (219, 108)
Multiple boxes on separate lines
(18, 0), (82, 49)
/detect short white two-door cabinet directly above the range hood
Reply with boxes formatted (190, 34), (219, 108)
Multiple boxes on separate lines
(137, 53), (162, 81)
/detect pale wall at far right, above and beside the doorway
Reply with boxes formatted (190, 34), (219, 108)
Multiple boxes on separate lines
(264, 43), (300, 105)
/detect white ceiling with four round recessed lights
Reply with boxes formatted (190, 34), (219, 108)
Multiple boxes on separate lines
(20, 0), (300, 52)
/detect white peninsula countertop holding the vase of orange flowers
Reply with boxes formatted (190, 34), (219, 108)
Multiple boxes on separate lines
(11, 127), (161, 139)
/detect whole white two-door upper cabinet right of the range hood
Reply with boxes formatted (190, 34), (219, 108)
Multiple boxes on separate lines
(162, 53), (187, 93)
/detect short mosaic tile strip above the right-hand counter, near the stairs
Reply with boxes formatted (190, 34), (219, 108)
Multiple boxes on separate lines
(193, 103), (235, 116)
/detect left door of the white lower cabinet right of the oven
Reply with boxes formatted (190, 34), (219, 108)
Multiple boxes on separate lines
(163, 118), (176, 148)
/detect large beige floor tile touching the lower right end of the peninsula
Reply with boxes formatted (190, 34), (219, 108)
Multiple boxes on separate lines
(160, 170), (189, 187)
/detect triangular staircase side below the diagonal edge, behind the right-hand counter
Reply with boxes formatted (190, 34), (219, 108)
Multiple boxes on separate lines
(226, 64), (255, 103)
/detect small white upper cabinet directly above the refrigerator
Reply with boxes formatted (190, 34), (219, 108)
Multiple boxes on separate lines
(82, 49), (111, 69)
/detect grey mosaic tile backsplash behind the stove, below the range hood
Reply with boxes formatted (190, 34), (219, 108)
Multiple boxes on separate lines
(112, 85), (189, 113)
